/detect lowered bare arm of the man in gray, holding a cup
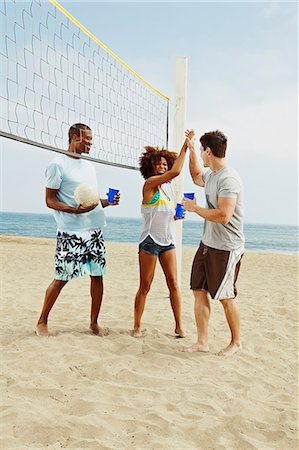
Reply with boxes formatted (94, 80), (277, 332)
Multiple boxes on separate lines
(183, 197), (237, 225)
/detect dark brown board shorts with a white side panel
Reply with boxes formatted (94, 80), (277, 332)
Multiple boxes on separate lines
(190, 242), (244, 300)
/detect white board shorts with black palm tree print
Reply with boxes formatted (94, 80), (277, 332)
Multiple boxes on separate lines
(55, 229), (106, 281)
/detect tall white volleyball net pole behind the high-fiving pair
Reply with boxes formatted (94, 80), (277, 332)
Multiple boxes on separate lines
(173, 57), (188, 284)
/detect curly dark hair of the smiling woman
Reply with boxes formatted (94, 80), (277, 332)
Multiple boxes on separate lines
(139, 146), (178, 180)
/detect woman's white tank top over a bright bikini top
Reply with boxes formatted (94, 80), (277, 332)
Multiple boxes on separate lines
(139, 189), (175, 245)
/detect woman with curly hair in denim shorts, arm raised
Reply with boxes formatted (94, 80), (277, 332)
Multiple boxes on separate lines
(134, 141), (188, 337)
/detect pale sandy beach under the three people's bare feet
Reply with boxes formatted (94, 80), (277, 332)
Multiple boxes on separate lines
(0, 236), (298, 450)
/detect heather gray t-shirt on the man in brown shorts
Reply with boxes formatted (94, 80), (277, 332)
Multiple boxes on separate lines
(202, 167), (244, 250)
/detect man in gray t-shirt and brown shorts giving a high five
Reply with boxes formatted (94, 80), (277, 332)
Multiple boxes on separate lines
(183, 130), (244, 356)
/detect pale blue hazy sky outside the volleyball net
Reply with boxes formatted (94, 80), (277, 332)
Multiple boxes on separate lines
(0, 1), (298, 225)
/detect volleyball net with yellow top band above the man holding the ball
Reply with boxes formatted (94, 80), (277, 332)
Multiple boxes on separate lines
(0, 0), (169, 169)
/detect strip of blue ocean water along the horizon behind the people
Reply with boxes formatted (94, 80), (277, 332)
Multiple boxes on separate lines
(0, 212), (298, 254)
